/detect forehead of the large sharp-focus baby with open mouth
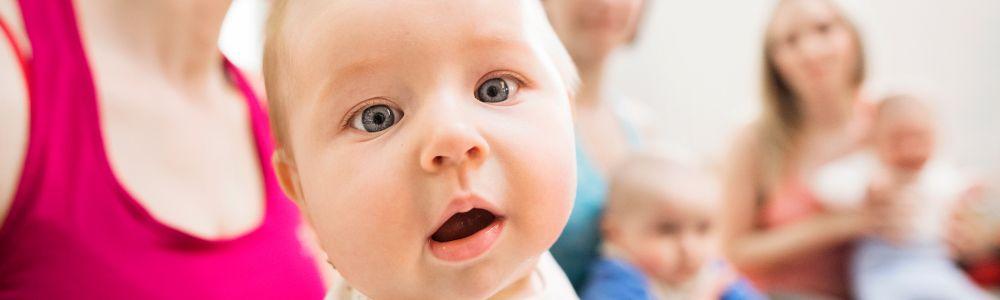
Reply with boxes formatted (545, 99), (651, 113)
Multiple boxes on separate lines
(282, 0), (536, 77)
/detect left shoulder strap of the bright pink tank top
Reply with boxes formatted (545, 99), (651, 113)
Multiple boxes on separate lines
(0, 0), (110, 240)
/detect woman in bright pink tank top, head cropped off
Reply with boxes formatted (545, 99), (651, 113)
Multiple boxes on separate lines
(0, 0), (324, 299)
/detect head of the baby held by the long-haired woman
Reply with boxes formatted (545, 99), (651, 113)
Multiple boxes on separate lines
(874, 95), (935, 172)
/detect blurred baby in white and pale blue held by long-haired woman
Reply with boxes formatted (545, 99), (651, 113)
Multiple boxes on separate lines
(811, 95), (987, 300)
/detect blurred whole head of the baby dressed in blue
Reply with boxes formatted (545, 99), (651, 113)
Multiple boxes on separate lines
(601, 155), (721, 285)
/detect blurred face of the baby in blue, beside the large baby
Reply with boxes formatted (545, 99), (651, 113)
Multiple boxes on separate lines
(615, 195), (715, 284)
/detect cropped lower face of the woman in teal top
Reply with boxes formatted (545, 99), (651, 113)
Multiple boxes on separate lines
(544, 0), (644, 63)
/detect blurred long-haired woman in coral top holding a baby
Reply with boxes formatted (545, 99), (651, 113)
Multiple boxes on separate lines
(725, 0), (874, 299)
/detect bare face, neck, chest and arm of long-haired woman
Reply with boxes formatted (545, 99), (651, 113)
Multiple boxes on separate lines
(723, 0), (872, 287)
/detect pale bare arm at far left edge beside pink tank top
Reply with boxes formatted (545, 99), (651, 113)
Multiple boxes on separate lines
(0, 5), (28, 224)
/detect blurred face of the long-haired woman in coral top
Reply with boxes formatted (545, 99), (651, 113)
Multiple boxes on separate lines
(768, 0), (860, 105)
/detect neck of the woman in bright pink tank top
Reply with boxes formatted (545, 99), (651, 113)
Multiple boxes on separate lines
(76, 0), (230, 88)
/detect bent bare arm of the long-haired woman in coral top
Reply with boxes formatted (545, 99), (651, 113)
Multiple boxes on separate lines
(723, 126), (865, 272)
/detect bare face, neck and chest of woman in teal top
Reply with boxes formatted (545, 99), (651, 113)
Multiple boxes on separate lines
(543, 0), (644, 175)
